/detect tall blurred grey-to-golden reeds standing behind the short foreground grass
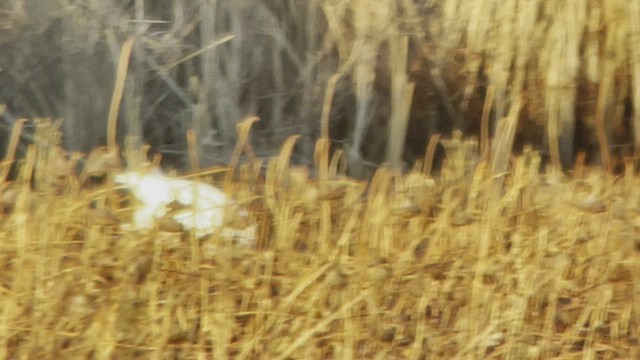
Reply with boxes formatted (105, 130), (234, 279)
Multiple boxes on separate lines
(0, 0), (640, 176)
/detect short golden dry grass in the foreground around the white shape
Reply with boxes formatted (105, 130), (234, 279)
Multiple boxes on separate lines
(0, 131), (640, 359)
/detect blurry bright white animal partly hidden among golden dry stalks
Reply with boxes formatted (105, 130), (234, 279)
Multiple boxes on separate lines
(114, 170), (255, 242)
